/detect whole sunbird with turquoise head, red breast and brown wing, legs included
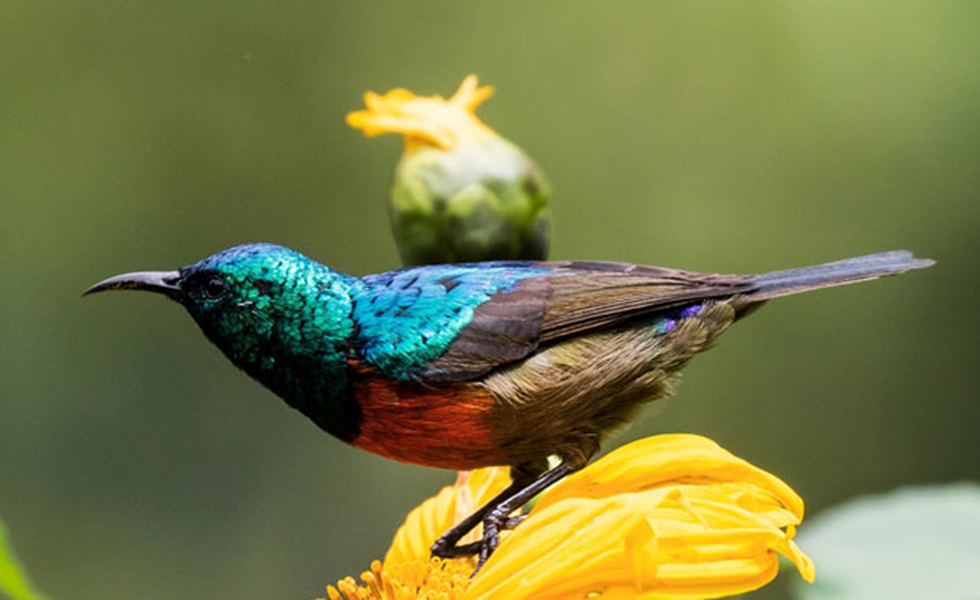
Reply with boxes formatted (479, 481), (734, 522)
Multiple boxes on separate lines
(85, 244), (934, 565)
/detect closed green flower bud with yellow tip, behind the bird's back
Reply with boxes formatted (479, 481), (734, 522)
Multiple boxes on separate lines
(347, 75), (551, 265)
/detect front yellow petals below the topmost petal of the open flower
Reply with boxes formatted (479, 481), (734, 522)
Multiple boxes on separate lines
(467, 490), (801, 598)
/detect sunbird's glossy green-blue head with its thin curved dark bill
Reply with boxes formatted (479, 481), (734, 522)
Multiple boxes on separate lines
(85, 244), (345, 369)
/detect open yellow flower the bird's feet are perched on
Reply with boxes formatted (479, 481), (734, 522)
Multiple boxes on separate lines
(322, 434), (814, 600)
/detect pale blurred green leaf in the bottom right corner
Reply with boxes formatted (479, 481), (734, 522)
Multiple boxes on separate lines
(794, 483), (980, 600)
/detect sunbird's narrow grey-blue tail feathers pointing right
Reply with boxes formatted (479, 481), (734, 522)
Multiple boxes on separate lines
(746, 250), (935, 303)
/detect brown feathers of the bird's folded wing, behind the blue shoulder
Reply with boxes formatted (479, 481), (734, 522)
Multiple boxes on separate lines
(421, 261), (756, 381)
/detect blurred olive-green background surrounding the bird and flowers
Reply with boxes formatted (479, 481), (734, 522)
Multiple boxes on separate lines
(0, 0), (980, 599)
